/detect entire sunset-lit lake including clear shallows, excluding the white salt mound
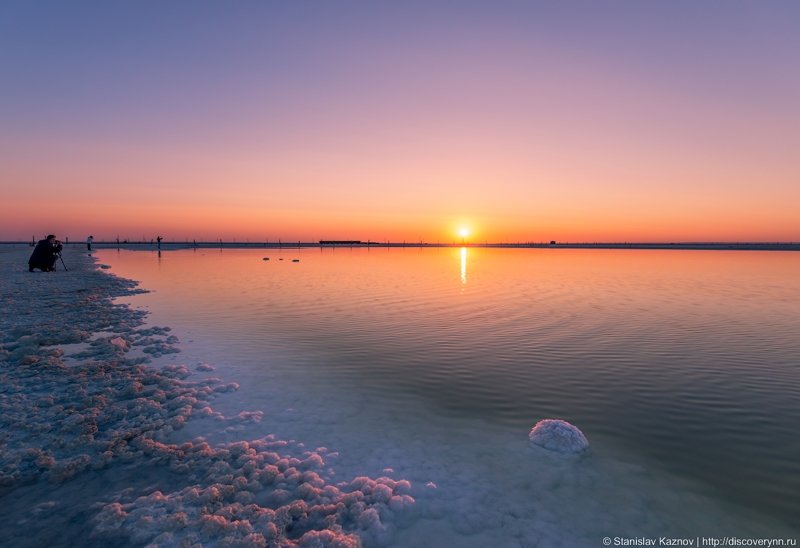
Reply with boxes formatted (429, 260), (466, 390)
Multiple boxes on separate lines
(98, 248), (800, 546)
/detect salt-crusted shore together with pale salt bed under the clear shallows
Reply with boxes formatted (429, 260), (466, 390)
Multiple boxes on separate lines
(0, 247), (796, 547)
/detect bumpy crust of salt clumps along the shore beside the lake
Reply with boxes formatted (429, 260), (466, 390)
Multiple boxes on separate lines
(0, 248), (415, 547)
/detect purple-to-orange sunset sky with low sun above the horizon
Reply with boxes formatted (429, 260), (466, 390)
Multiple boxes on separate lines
(0, 0), (800, 242)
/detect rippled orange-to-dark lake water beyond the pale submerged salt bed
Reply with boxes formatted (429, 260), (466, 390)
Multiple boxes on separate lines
(100, 248), (800, 523)
